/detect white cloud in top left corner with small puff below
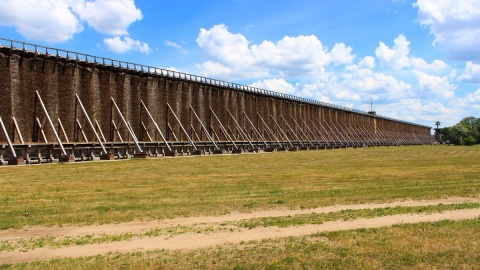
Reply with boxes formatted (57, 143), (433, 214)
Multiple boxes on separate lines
(0, 0), (150, 53)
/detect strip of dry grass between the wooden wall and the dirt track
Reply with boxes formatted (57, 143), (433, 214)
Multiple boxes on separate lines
(0, 146), (480, 229)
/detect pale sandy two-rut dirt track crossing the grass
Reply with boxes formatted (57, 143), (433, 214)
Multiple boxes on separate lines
(0, 198), (480, 263)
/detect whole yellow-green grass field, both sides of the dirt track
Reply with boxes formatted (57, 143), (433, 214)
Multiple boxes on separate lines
(0, 146), (480, 269)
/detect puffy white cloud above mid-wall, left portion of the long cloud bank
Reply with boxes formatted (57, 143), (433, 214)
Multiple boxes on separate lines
(193, 24), (354, 79)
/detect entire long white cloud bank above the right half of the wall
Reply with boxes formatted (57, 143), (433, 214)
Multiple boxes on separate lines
(193, 24), (466, 124)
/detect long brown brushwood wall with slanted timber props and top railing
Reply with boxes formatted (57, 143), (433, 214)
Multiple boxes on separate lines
(0, 39), (434, 164)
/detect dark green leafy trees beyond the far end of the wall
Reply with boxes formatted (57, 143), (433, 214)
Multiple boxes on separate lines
(440, 116), (480, 145)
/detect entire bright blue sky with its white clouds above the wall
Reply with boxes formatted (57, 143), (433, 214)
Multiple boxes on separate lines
(0, 0), (480, 126)
